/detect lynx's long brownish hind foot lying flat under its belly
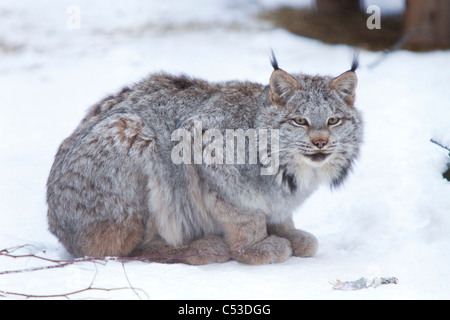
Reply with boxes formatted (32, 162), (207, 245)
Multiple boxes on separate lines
(132, 235), (231, 265)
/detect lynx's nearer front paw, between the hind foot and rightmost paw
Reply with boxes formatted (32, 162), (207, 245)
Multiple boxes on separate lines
(233, 235), (292, 265)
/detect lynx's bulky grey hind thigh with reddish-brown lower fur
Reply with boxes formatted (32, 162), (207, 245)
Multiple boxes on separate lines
(47, 114), (152, 257)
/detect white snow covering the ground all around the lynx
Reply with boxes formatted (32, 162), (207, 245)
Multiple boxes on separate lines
(0, 0), (450, 299)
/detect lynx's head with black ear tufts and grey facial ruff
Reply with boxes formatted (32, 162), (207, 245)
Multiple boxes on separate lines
(266, 51), (363, 189)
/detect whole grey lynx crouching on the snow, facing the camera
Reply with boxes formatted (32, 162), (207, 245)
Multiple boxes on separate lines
(47, 55), (363, 265)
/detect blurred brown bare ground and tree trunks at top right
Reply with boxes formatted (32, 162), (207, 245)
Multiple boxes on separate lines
(261, 0), (450, 51)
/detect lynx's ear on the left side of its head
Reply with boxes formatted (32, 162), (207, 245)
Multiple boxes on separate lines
(270, 69), (301, 104)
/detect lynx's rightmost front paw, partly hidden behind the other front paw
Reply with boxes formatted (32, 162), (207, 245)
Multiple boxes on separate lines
(267, 219), (319, 258)
